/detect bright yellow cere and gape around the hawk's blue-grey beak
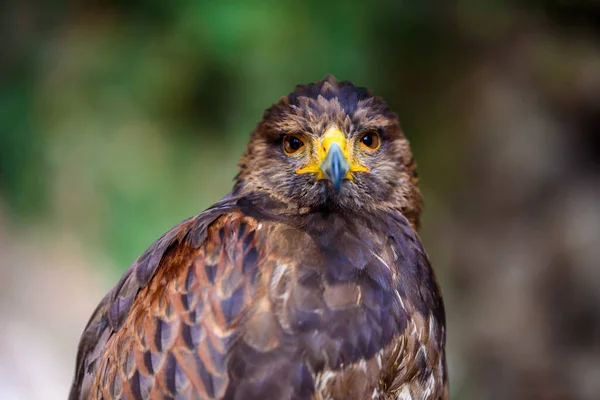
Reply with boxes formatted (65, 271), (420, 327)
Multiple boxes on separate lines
(296, 125), (370, 180)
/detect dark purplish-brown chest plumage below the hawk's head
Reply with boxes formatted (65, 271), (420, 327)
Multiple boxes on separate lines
(229, 217), (446, 399)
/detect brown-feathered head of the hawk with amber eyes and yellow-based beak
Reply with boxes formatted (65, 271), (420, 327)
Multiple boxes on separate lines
(235, 76), (421, 227)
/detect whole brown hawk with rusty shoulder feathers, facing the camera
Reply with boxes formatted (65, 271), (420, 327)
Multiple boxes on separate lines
(70, 76), (448, 400)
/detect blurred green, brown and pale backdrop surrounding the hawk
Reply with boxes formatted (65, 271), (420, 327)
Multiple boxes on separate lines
(0, 0), (600, 400)
